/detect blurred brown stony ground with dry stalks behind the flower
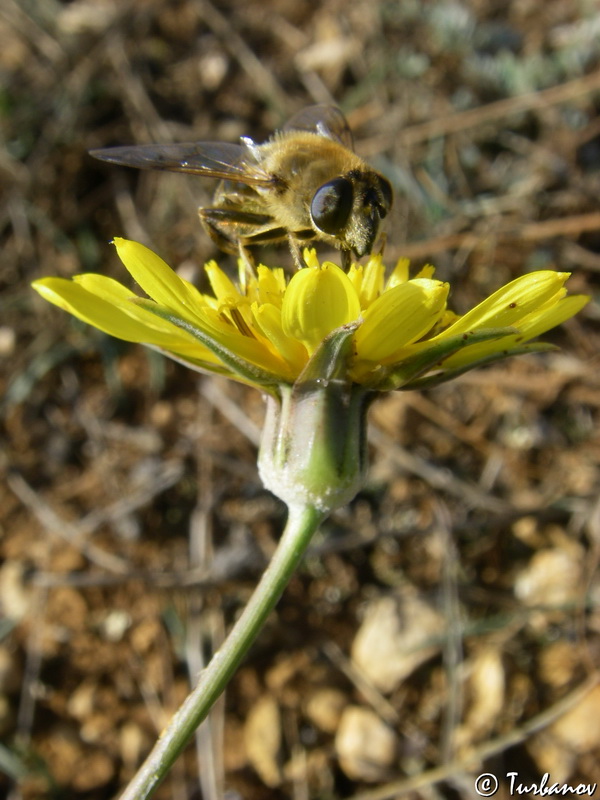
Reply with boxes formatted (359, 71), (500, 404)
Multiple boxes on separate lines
(0, 0), (600, 800)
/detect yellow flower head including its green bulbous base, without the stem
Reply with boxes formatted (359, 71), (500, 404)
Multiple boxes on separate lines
(33, 239), (588, 513)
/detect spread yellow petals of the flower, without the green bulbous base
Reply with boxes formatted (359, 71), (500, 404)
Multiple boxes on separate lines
(33, 239), (588, 393)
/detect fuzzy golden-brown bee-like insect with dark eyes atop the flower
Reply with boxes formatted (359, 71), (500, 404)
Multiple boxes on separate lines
(90, 105), (392, 263)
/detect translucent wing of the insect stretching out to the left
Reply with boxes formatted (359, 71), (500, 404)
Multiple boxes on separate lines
(90, 142), (274, 186)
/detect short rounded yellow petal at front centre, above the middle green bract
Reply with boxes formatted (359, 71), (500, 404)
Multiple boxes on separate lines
(281, 262), (360, 354)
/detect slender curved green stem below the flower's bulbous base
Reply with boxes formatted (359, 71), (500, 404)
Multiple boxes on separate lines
(121, 506), (326, 800)
